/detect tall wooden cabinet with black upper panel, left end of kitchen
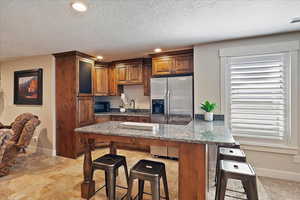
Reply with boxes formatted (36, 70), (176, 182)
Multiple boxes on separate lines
(54, 51), (94, 158)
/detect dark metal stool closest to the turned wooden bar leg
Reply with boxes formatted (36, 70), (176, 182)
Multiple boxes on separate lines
(92, 154), (129, 200)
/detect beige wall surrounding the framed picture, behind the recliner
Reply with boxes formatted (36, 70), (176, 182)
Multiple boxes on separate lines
(0, 55), (55, 154)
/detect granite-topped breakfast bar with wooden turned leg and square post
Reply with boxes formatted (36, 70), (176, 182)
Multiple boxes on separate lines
(75, 120), (234, 200)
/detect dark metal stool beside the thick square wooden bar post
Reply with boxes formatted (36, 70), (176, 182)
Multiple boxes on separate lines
(127, 160), (169, 200)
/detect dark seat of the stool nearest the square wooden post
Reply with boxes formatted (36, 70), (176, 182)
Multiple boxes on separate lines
(130, 160), (165, 177)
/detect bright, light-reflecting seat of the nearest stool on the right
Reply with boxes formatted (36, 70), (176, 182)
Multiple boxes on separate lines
(220, 160), (255, 176)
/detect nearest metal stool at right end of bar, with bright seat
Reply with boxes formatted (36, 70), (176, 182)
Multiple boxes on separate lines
(215, 160), (258, 200)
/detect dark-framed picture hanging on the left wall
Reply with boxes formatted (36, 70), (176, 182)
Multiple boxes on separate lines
(14, 69), (43, 105)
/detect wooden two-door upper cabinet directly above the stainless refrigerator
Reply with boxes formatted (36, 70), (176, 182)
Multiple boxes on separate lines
(151, 50), (194, 76)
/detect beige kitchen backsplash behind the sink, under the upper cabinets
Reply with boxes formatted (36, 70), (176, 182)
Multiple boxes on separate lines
(96, 85), (150, 109)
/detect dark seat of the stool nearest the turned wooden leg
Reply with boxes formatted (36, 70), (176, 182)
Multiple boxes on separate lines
(93, 154), (125, 168)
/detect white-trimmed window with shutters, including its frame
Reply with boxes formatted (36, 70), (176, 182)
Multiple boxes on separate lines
(219, 41), (300, 148)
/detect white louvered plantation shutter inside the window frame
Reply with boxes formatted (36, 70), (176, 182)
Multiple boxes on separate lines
(227, 53), (289, 139)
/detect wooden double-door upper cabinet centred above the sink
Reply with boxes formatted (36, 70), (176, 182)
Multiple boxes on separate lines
(115, 60), (143, 85)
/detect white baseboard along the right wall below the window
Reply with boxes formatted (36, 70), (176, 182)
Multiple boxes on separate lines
(255, 168), (300, 182)
